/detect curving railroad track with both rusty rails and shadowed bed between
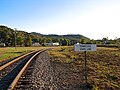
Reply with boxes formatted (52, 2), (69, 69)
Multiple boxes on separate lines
(0, 49), (47, 90)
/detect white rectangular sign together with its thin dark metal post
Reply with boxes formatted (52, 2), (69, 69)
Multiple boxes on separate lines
(74, 44), (96, 83)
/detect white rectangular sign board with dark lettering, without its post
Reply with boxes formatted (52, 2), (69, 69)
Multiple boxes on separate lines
(74, 44), (96, 51)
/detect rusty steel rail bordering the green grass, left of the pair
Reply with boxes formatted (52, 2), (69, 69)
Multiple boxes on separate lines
(0, 50), (39, 71)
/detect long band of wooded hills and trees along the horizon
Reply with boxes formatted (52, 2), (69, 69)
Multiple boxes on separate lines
(0, 25), (116, 47)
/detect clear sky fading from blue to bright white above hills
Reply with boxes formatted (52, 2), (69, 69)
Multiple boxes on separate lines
(0, 0), (120, 39)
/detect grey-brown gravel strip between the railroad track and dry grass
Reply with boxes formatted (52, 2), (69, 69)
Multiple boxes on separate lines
(17, 52), (83, 90)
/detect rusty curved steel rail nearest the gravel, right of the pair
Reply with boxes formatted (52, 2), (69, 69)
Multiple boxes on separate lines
(7, 49), (47, 90)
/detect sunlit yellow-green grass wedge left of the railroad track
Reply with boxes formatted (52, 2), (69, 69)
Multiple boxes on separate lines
(0, 47), (51, 62)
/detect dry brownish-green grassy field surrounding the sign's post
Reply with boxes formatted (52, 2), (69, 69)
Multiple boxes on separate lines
(49, 47), (120, 90)
